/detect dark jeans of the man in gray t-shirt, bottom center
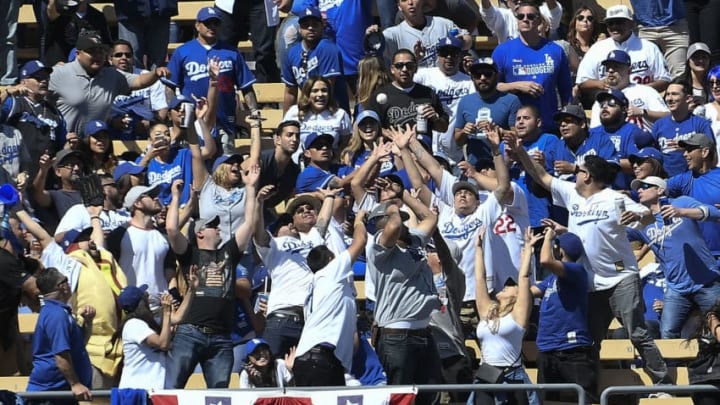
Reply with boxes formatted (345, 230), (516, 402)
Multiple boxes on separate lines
(377, 329), (442, 405)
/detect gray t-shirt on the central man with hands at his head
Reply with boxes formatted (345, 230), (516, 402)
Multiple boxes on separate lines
(365, 228), (440, 327)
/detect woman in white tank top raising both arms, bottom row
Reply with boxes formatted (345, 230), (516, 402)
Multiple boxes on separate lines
(473, 227), (542, 405)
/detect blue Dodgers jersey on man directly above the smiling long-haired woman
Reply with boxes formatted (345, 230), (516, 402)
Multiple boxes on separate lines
(282, 39), (350, 111)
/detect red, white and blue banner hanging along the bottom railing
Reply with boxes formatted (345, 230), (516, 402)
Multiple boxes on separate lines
(150, 386), (417, 405)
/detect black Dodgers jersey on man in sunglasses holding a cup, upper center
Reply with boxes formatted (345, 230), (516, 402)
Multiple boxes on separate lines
(368, 83), (448, 134)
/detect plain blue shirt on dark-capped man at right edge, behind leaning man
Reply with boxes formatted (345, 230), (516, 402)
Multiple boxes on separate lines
(667, 167), (720, 258)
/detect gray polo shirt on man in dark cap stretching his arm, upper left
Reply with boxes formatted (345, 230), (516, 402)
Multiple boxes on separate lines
(49, 59), (136, 135)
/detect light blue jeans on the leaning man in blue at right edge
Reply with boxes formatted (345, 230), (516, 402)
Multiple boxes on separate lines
(660, 281), (720, 339)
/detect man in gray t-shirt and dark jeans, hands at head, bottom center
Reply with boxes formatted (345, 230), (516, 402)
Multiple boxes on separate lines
(366, 190), (441, 404)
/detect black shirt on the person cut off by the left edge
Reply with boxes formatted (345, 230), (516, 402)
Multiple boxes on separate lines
(0, 249), (30, 349)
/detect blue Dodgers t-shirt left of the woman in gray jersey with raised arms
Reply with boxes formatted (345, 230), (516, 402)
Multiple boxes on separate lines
(135, 146), (192, 205)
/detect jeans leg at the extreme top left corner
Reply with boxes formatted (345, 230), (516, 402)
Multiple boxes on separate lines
(0, 0), (22, 86)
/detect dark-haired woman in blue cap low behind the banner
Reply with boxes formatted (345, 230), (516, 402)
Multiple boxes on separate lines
(240, 338), (295, 388)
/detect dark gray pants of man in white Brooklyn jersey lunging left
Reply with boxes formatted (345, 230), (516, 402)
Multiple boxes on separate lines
(588, 273), (670, 383)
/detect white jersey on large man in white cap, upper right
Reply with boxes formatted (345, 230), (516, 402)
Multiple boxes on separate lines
(575, 34), (672, 84)
